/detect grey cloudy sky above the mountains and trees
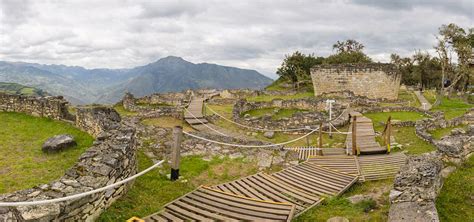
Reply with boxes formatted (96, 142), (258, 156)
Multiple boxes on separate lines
(0, 0), (474, 79)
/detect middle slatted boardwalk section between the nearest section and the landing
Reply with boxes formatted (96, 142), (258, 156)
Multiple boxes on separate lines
(213, 162), (357, 215)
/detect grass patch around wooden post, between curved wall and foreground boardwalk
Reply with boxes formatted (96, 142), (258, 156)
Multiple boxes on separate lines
(97, 152), (257, 222)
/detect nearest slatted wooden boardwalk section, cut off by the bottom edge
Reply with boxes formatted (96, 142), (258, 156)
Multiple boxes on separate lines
(144, 187), (294, 221)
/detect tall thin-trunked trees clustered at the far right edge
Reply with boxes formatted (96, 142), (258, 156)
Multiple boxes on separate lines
(391, 24), (474, 91)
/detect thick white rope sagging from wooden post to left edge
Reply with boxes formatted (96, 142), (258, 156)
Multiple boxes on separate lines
(0, 160), (164, 207)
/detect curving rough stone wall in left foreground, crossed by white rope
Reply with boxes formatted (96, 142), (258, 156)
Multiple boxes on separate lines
(0, 108), (137, 221)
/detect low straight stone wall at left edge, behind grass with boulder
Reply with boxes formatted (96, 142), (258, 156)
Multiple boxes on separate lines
(0, 93), (74, 120)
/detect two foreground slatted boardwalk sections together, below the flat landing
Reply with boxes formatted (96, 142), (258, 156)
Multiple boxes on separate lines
(145, 162), (358, 221)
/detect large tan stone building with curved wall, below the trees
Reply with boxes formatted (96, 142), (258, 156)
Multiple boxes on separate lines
(311, 63), (401, 99)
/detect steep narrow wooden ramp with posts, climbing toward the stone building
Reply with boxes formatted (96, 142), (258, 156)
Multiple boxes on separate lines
(346, 112), (387, 155)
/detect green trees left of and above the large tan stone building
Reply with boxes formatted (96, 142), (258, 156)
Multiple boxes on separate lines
(277, 39), (372, 89)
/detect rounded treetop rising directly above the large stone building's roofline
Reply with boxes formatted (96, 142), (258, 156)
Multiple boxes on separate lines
(324, 39), (372, 64)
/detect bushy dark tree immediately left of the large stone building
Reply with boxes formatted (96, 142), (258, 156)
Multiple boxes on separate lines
(277, 51), (324, 89)
